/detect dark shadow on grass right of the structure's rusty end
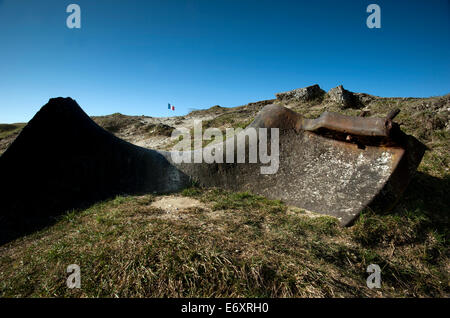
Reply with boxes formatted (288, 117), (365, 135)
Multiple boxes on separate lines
(354, 172), (450, 249)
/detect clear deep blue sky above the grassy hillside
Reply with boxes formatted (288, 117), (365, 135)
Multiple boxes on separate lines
(0, 0), (450, 123)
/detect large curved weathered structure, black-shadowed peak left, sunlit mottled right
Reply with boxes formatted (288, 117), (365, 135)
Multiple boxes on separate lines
(0, 98), (425, 242)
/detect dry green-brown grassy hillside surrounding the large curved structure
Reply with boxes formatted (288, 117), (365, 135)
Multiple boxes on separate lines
(0, 90), (450, 297)
